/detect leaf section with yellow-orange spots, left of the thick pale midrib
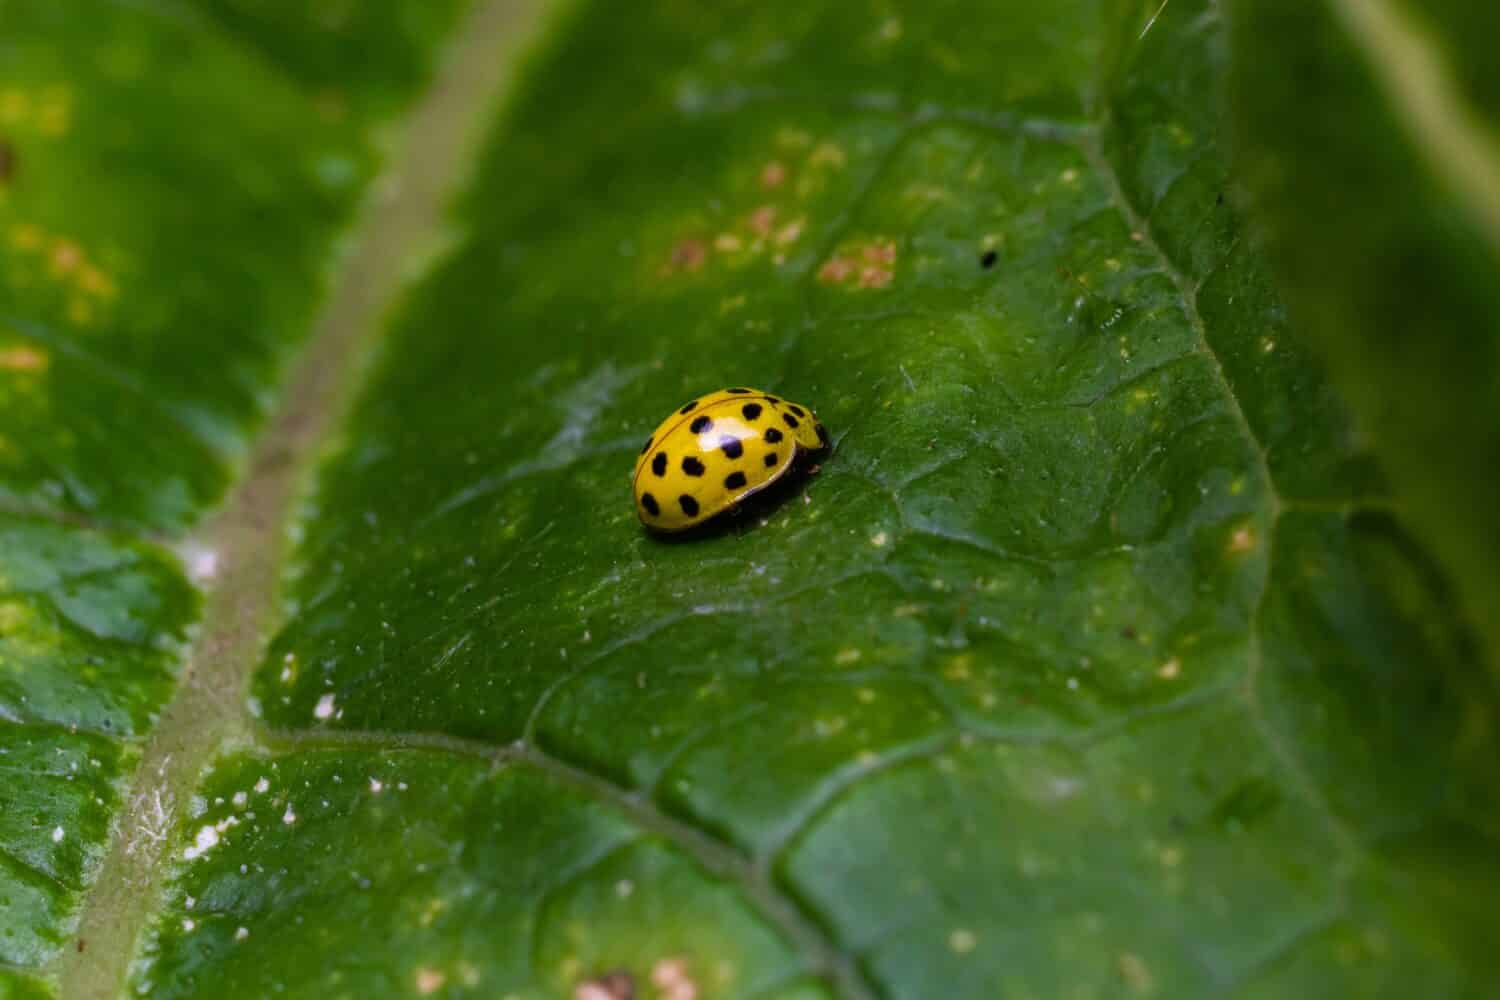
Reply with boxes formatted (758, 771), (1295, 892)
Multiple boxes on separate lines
(0, 0), (455, 997)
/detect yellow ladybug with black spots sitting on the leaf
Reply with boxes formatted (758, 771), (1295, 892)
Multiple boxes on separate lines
(632, 388), (828, 532)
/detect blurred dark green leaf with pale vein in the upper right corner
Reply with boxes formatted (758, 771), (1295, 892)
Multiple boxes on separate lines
(1229, 0), (1500, 670)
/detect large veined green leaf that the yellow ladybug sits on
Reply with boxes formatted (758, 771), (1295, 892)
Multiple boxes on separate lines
(0, 0), (1500, 1000)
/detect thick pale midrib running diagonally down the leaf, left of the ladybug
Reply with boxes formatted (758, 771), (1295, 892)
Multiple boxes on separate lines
(47, 0), (558, 1000)
